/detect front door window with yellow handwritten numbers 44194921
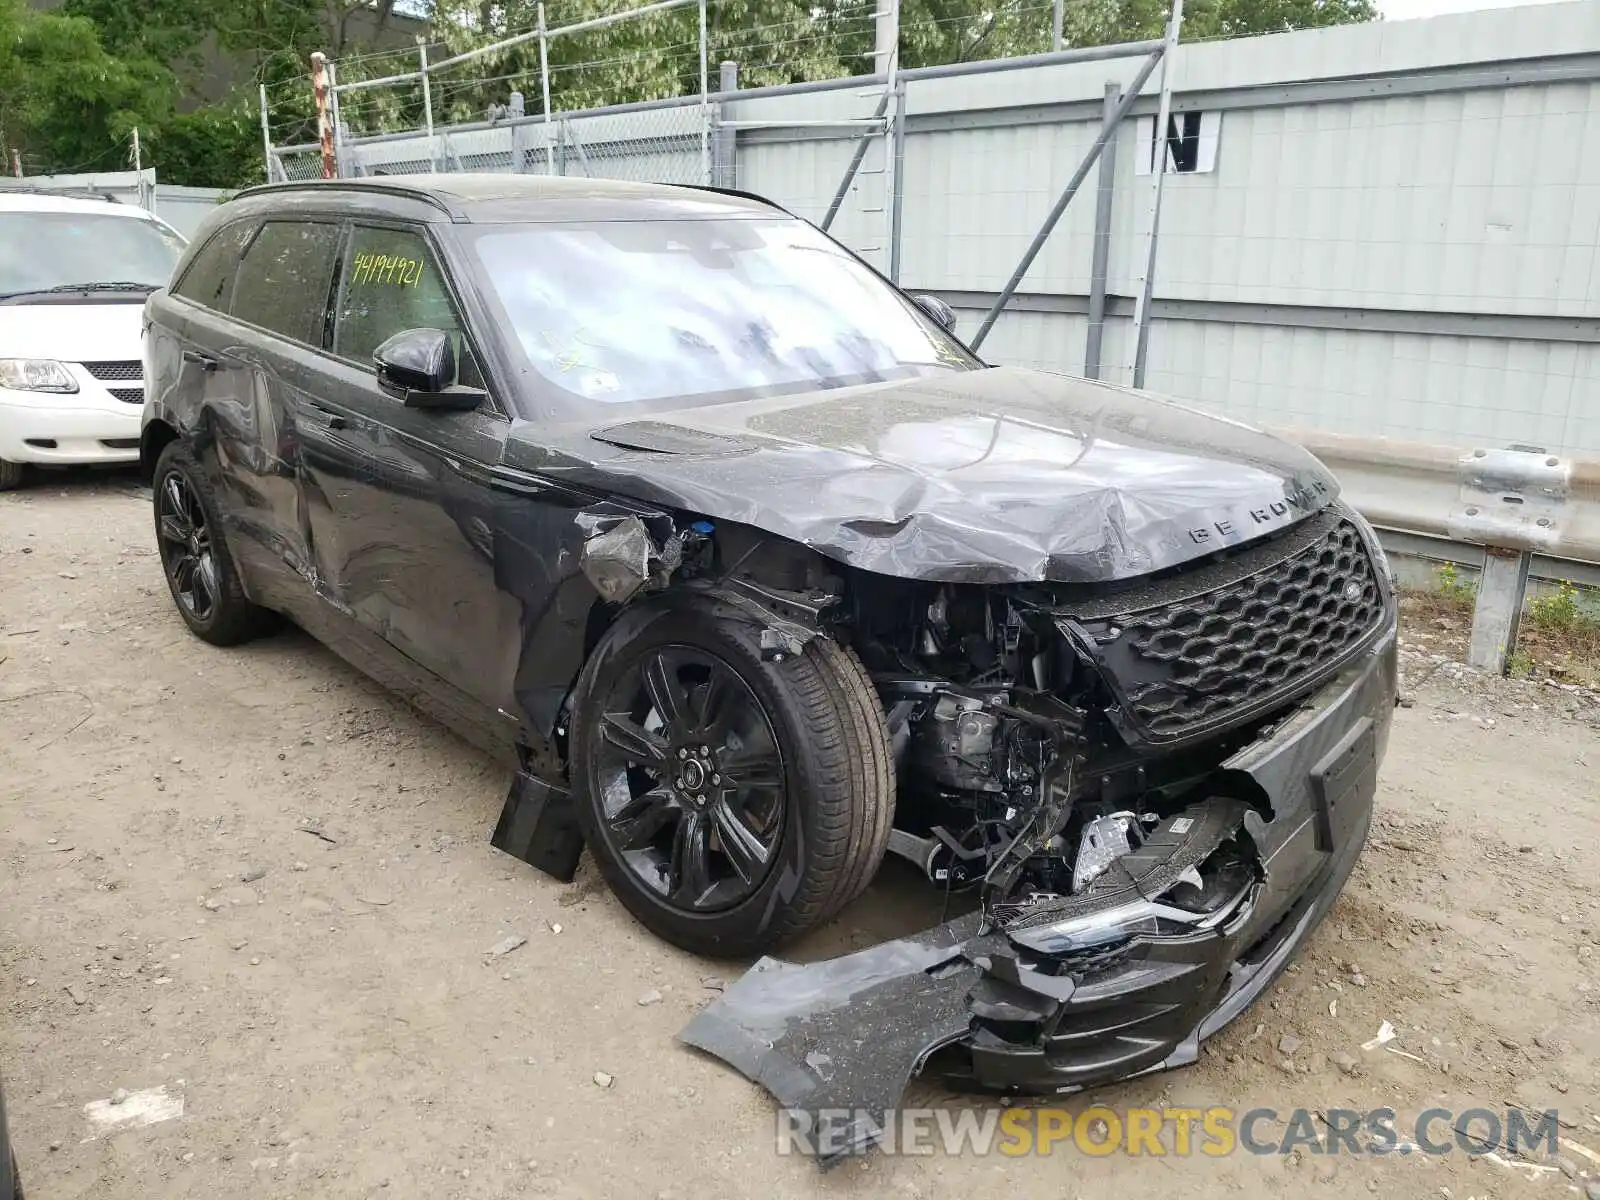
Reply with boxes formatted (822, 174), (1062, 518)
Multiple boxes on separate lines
(333, 226), (483, 387)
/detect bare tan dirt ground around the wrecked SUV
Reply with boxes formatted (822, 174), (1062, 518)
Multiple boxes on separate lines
(0, 475), (1600, 1200)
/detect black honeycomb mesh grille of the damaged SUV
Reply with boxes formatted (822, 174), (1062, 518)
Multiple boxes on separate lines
(1094, 520), (1386, 741)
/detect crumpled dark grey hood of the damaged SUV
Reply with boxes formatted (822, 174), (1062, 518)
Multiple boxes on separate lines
(507, 366), (1338, 584)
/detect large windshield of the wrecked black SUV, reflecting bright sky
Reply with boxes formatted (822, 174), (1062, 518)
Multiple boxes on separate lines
(475, 218), (981, 405)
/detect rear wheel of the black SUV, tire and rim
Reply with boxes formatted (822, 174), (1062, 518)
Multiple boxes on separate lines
(152, 442), (274, 646)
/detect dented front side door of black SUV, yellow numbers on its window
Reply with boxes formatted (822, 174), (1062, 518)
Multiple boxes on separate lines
(301, 224), (518, 720)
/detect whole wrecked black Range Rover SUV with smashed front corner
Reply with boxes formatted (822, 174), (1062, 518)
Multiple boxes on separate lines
(141, 176), (1395, 1120)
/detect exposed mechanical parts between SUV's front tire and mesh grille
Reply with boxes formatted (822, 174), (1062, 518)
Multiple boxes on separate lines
(851, 581), (1267, 926)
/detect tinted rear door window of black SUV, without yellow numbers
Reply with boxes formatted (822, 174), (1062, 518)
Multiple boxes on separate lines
(232, 221), (339, 347)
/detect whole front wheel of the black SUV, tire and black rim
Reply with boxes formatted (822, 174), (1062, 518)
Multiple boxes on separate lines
(571, 605), (894, 957)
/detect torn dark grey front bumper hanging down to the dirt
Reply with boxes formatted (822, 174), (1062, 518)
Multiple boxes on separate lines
(678, 627), (1395, 1166)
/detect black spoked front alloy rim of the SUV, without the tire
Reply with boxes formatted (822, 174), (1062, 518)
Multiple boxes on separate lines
(595, 645), (784, 912)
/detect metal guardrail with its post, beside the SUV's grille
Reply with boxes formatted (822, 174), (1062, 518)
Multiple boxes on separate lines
(1272, 427), (1600, 674)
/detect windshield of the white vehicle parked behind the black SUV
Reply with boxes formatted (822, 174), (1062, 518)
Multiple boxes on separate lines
(0, 205), (184, 296)
